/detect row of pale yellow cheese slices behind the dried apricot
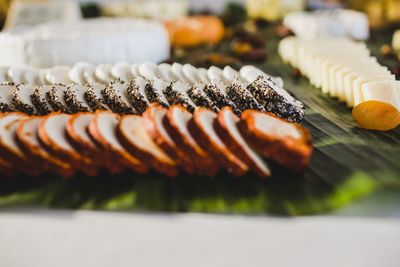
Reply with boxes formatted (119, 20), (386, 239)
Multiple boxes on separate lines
(279, 37), (397, 110)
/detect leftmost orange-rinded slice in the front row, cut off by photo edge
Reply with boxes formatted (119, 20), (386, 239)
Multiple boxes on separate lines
(0, 113), (42, 176)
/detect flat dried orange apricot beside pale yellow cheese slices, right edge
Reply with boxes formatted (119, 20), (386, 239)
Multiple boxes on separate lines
(352, 100), (400, 131)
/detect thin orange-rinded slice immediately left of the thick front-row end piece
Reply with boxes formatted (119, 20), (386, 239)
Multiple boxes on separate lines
(215, 107), (271, 177)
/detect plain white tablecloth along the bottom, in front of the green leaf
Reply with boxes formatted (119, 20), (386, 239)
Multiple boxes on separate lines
(0, 210), (400, 267)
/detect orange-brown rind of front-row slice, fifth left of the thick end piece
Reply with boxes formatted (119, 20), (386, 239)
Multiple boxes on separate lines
(117, 115), (178, 177)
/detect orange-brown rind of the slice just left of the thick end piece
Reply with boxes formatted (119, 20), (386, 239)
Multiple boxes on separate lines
(214, 107), (270, 177)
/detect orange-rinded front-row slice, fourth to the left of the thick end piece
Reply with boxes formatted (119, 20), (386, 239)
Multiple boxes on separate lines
(142, 103), (194, 173)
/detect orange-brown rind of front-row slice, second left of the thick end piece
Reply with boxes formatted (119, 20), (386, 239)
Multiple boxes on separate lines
(188, 108), (249, 176)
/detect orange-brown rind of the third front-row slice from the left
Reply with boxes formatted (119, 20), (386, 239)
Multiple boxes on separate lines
(39, 112), (98, 176)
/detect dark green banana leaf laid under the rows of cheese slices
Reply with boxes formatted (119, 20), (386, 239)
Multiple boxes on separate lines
(0, 18), (400, 215)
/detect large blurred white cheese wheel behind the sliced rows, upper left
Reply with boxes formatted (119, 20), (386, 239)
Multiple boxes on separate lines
(0, 18), (170, 67)
